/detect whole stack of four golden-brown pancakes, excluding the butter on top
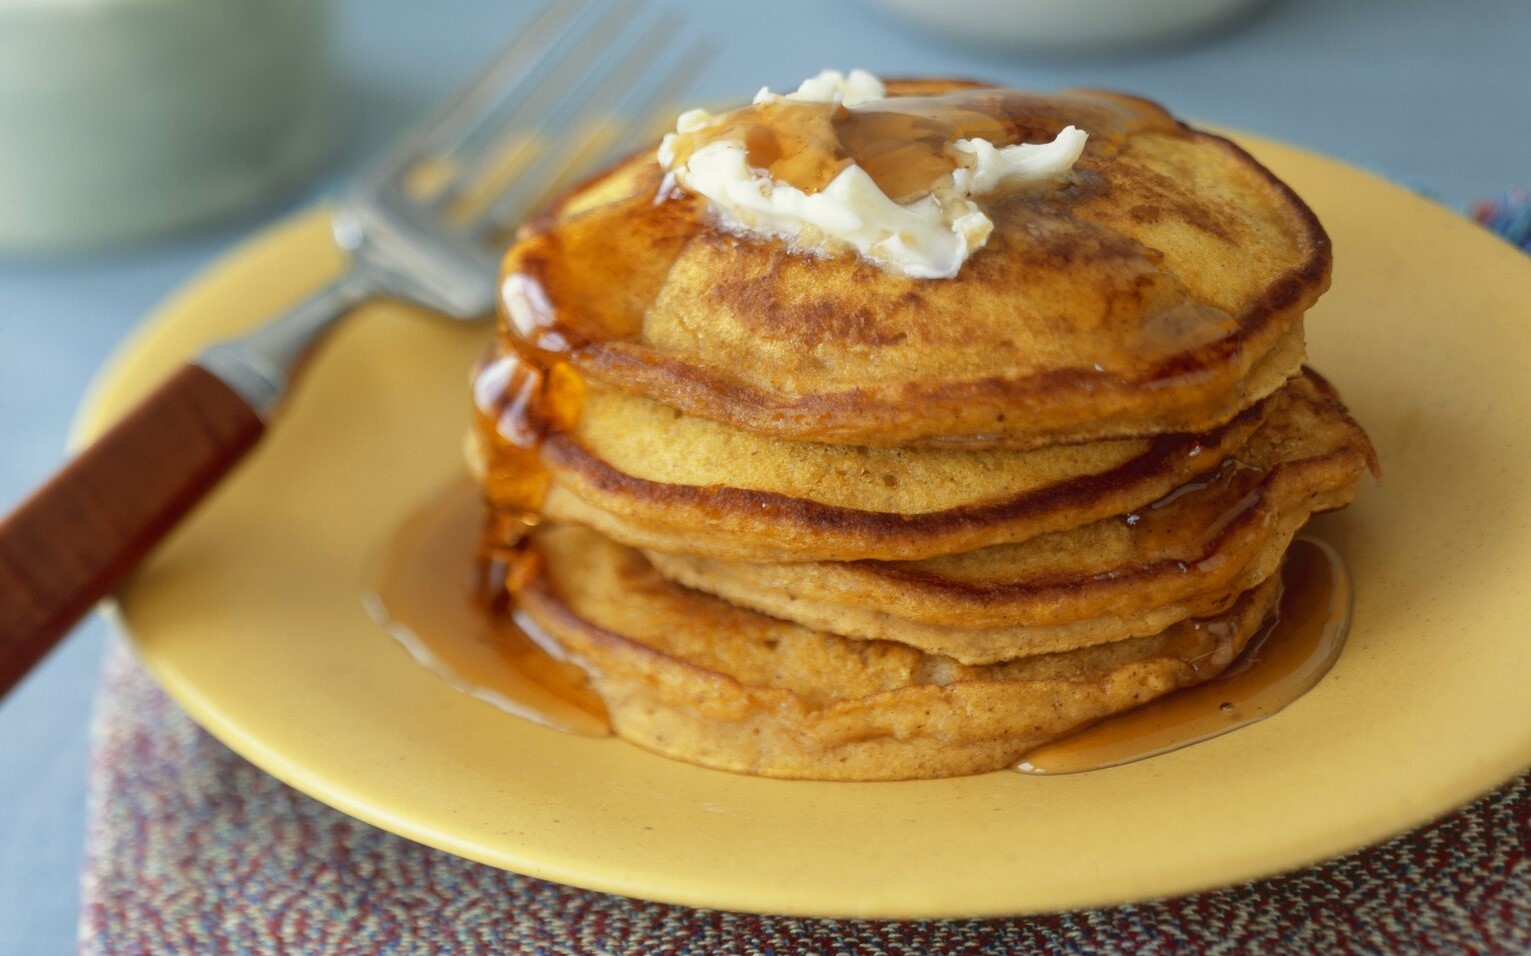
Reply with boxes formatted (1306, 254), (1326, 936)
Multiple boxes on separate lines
(472, 81), (1373, 780)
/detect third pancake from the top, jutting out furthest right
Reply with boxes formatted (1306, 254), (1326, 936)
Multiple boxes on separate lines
(648, 372), (1373, 663)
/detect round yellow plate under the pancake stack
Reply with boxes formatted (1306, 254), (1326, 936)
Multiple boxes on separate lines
(83, 141), (1531, 918)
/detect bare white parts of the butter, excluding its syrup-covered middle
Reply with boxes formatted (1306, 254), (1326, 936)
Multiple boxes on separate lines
(658, 70), (1087, 279)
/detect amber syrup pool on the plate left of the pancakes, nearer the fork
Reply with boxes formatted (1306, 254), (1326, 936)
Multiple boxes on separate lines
(364, 483), (611, 735)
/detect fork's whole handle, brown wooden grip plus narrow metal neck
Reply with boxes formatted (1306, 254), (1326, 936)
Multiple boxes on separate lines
(0, 268), (375, 699)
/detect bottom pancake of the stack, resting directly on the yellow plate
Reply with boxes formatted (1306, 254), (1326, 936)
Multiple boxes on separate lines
(516, 525), (1280, 780)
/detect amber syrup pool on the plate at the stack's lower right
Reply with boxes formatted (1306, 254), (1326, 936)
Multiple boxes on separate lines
(1017, 539), (1350, 774)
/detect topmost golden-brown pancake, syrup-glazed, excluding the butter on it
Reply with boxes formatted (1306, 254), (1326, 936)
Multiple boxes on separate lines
(504, 81), (1330, 447)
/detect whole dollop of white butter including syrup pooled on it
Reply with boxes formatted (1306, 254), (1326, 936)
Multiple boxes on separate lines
(658, 70), (1087, 279)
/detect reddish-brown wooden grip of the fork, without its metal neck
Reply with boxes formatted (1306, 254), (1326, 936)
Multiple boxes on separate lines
(0, 365), (265, 697)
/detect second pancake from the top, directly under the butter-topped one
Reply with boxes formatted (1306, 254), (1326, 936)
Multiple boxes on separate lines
(470, 376), (1266, 561)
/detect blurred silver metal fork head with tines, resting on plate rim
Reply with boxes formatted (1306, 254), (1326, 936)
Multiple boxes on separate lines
(334, 0), (706, 319)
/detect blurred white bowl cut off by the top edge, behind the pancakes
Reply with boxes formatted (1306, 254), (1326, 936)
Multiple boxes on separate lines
(867, 0), (1268, 54)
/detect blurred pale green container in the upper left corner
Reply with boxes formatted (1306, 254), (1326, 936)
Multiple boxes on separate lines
(0, 0), (334, 253)
